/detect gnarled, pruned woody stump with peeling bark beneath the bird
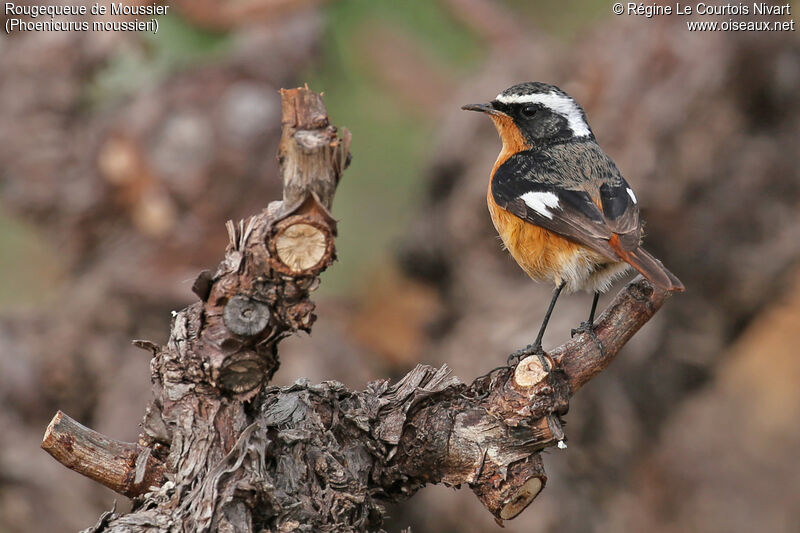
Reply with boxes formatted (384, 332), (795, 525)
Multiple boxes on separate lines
(45, 88), (666, 532)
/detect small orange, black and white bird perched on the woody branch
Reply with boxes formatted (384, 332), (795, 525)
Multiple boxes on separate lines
(461, 82), (684, 370)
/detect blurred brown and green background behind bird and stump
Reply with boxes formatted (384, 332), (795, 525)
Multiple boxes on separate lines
(0, 0), (800, 533)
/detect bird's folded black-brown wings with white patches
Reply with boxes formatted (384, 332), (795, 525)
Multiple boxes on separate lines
(492, 152), (641, 260)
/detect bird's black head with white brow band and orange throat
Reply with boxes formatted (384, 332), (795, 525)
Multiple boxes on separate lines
(461, 82), (594, 147)
